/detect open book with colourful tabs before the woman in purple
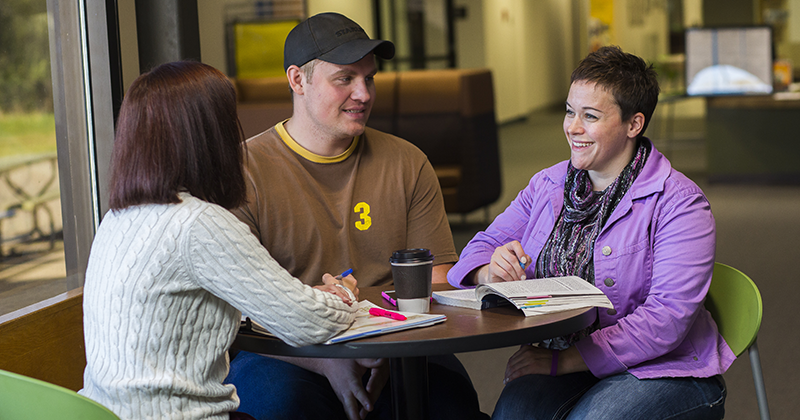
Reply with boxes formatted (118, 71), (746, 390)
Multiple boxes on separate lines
(433, 276), (614, 316)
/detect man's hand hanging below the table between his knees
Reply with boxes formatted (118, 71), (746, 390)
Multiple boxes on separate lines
(322, 359), (389, 420)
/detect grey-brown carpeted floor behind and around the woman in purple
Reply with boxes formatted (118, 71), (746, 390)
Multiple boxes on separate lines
(453, 111), (800, 420)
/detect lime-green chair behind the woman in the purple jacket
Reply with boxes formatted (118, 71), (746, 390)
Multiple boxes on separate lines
(705, 263), (770, 420)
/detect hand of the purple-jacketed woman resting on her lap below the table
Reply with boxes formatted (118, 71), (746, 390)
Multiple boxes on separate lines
(503, 344), (589, 384)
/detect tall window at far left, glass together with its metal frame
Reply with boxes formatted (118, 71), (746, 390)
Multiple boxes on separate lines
(0, 0), (119, 316)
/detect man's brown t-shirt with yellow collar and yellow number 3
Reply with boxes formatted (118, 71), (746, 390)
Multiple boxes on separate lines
(234, 123), (458, 287)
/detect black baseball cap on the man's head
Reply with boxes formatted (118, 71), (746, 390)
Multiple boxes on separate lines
(283, 13), (394, 71)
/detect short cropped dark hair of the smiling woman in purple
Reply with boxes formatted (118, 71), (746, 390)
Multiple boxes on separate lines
(570, 46), (659, 137)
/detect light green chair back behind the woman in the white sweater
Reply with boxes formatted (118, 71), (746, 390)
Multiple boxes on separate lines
(0, 370), (119, 420)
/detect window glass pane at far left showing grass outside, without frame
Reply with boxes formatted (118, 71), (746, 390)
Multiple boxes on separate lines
(0, 0), (66, 315)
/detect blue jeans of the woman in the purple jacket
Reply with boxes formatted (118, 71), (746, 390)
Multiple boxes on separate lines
(492, 372), (727, 420)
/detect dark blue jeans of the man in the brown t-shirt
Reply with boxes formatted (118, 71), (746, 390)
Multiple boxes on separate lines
(225, 351), (489, 420)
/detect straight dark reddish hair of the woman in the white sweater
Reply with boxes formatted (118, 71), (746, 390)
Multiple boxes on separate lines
(109, 61), (246, 210)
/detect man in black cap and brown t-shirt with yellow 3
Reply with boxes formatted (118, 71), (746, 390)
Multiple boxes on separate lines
(227, 13), (488, 420)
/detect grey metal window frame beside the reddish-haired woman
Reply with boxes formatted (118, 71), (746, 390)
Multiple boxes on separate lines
(47, 0), (120, 290)
